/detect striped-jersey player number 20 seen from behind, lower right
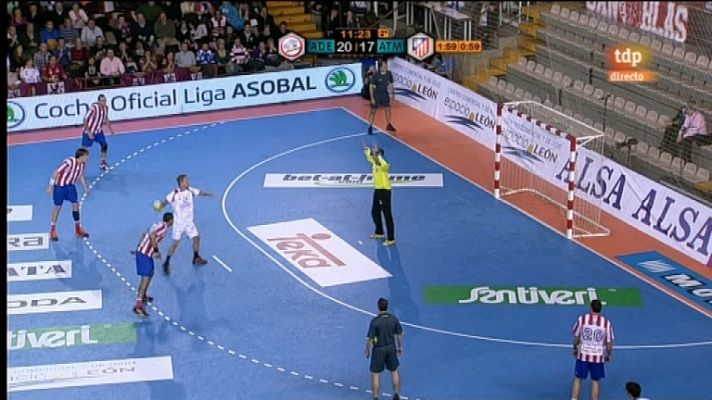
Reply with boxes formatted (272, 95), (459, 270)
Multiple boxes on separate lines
(571, 300), (615, 400)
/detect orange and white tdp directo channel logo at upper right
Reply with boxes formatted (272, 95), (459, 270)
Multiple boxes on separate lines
(608, 45), (655, 83)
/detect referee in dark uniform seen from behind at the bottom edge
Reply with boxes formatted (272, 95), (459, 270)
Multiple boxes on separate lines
(366, 298), (403, 400)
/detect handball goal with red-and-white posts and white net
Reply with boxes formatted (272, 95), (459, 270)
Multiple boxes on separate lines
(495, 101), (610, 238)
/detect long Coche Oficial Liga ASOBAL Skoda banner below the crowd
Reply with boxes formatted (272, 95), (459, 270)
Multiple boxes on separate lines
(7, 63), (362, 132)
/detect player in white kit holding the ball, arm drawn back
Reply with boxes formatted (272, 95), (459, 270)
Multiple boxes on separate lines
(155, 175), (213, 274)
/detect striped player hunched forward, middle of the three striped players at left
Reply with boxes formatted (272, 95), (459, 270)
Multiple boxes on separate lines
(47, 149), (89, 242)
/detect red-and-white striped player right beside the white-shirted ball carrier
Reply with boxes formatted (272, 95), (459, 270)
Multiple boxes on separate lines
(134, 213), (173, 317)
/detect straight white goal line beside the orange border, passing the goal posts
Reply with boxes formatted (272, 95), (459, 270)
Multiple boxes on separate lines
(341, 107), (712, 318)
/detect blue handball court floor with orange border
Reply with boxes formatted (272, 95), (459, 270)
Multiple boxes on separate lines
(8, 97), (712, 399)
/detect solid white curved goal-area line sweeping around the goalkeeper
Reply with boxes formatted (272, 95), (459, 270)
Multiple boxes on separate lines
(222, 110), (712, 350)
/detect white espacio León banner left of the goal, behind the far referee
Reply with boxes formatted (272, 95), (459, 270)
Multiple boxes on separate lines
(388, 58), (497, 148)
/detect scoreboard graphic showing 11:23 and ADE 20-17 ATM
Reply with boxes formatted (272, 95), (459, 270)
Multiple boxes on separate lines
(279, 28), (483, 61)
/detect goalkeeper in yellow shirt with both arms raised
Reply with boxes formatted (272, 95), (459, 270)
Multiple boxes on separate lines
(364, 145), (396, 246)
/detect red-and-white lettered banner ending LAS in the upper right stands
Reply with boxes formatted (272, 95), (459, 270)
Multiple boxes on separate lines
(586, 1), (702, 43)
